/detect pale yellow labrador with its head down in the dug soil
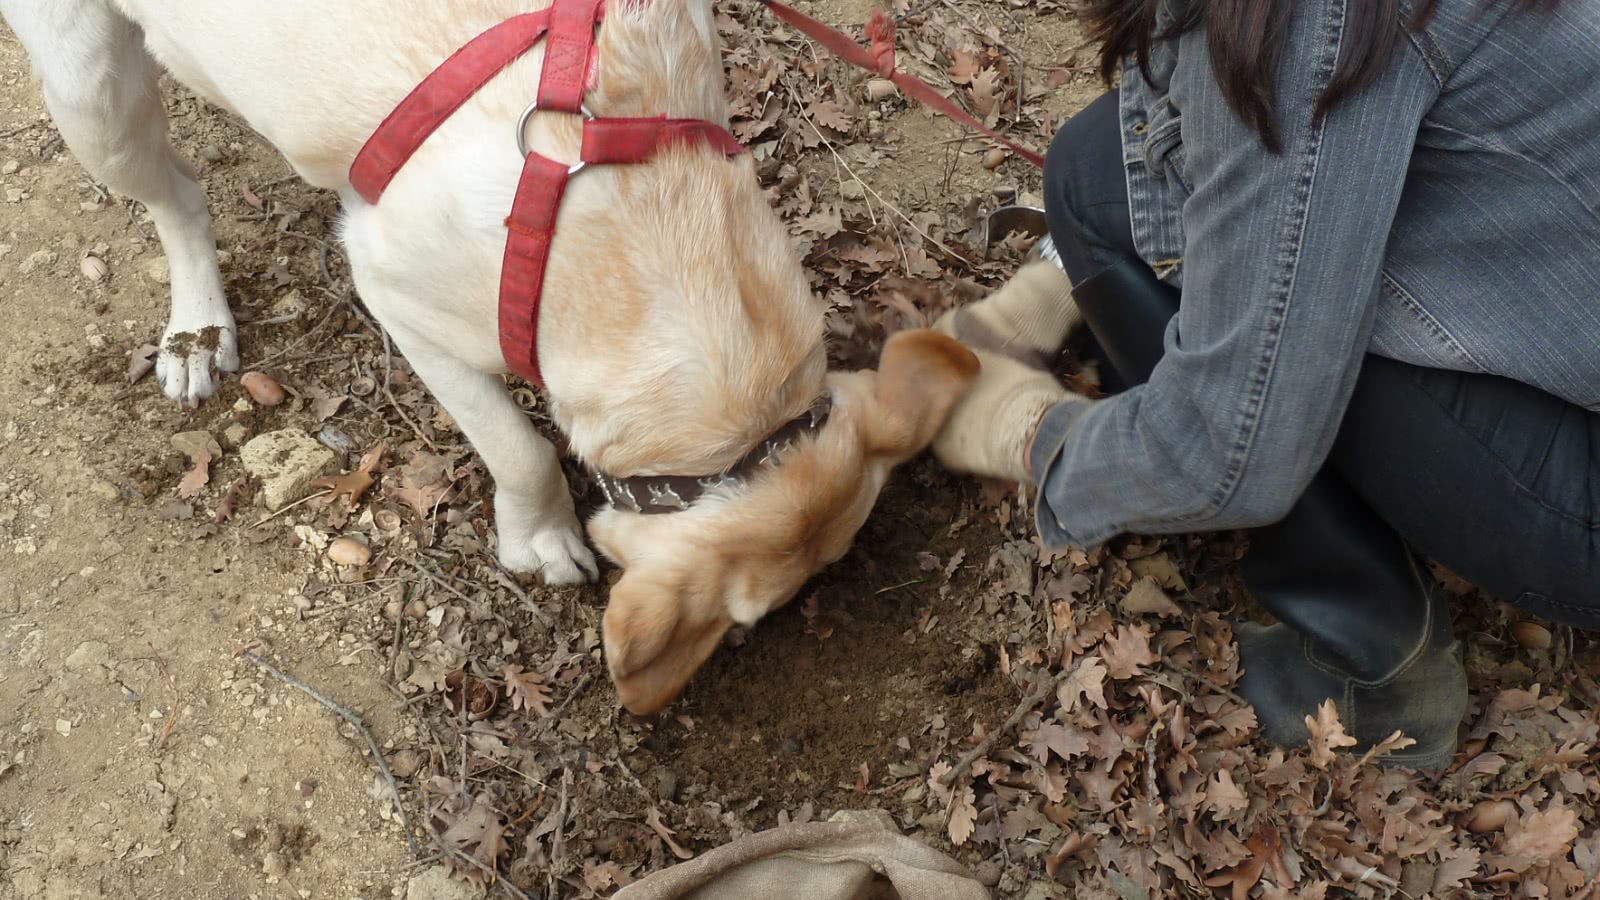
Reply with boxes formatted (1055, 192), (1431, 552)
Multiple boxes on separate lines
(0, 0), (978, 713)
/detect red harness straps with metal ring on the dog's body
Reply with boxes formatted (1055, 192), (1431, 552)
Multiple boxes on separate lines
(350, 0), (744, 386)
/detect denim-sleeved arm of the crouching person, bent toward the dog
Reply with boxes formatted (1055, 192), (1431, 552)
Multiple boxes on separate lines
(1029, 0), (1438, 546)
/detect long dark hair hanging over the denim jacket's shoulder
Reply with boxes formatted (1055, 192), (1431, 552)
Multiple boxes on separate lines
(1077, 0), (1562, 152)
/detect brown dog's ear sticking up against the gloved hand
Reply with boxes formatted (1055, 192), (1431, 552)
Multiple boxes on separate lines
(867, 328), (978, 463)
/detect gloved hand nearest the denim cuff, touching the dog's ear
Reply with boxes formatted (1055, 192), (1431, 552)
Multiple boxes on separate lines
(933, 348), (1072, 484)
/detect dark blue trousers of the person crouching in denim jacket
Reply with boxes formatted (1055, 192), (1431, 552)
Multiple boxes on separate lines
(1035, 91), (1600, 629)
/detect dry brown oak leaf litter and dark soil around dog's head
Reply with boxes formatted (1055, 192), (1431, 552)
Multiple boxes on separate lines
(118, 0), (1600, 900)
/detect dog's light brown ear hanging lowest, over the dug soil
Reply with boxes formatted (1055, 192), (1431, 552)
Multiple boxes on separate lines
(603, 560), (733, 716)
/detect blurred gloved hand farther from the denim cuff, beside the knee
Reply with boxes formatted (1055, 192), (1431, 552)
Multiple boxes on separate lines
(933, 259), (1083, 370)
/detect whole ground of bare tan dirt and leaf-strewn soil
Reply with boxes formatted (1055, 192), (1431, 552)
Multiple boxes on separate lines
(0, 0), (1600, 900)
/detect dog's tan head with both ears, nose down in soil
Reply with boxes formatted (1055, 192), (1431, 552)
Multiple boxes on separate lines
(589, 330), (978, 714)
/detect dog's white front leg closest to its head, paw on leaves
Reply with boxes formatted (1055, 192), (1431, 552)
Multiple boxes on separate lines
(384, 331), (600, 585)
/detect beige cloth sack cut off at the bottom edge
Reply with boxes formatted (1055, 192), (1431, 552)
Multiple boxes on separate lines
(611, 822), (989, 900)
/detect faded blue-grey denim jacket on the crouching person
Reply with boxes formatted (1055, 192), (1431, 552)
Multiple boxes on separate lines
(1030, 0), (1600, 546)
